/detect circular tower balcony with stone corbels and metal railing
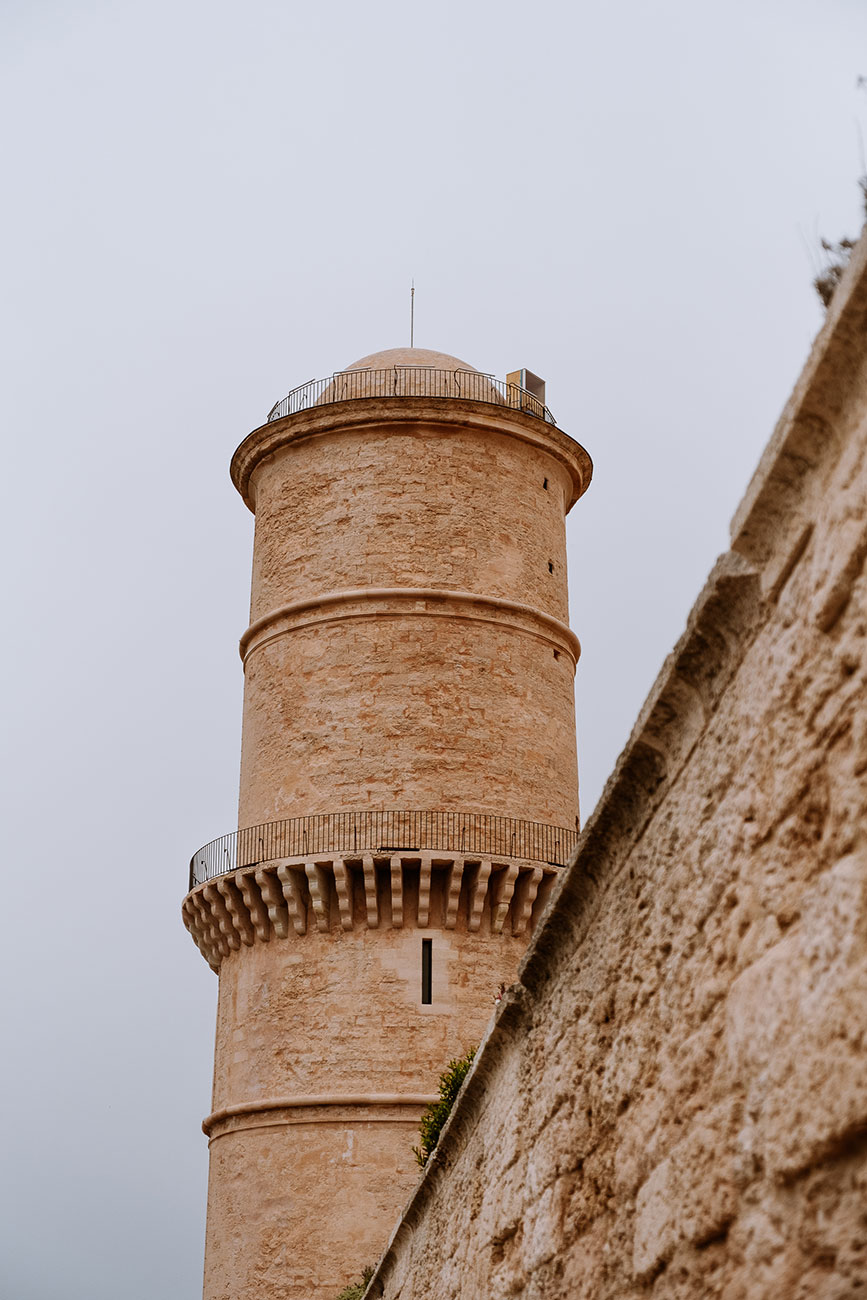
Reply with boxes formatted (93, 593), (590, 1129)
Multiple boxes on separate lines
(183, 810), (577, 971)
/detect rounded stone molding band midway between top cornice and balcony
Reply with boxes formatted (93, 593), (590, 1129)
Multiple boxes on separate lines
(239, 586), (581, 664)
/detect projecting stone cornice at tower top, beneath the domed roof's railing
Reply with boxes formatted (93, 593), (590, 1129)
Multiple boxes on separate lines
(230, 397), (593, 512)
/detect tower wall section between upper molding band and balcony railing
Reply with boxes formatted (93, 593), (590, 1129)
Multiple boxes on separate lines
(239, 599), (578, 827)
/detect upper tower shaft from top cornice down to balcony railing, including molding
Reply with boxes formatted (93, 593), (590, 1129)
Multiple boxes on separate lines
(233, 398), (590, 826)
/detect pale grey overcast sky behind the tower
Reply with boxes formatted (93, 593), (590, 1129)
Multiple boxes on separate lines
(0, 0), (867, 1300)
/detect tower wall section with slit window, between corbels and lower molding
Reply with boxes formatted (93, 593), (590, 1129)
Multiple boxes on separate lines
(213, 917), (526, 1107)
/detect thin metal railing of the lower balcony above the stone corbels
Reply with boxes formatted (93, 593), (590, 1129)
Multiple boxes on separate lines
(190, 810), (577, 889)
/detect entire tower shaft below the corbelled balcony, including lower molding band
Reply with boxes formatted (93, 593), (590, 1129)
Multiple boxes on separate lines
(205, 905), (525, 1300)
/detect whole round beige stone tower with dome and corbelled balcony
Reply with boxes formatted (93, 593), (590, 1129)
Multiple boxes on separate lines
(183, 348), (591, 1300)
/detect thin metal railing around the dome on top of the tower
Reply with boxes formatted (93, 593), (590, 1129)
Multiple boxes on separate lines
(266, 365), (556, 424)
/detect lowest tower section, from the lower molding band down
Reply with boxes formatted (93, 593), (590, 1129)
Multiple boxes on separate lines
(204, 1105), (421, 1300)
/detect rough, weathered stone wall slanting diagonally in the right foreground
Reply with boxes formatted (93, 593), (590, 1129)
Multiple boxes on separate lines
(369, 233), (867, 1300)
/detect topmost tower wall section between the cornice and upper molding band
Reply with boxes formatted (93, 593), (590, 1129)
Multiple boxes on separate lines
(251, 408), (572, 621)
